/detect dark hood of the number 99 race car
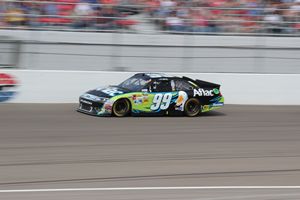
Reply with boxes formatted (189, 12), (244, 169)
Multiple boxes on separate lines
(85, 86), (130, 98)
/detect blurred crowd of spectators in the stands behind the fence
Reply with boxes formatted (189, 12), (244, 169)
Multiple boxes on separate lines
(0, 0), (300, 34)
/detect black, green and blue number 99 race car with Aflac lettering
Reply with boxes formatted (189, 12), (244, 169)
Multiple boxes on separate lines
(77, 73), (224, 117)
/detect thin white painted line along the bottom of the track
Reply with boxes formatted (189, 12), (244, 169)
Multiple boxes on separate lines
(0, 186), (300, 193)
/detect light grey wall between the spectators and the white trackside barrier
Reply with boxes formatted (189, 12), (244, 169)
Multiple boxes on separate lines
(0, 30), (300, 74)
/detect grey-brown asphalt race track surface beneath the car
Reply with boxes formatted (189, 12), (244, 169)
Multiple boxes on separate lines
(0, 104), (300, 200)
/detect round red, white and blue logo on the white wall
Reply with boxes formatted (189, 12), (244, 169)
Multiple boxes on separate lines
(0, 73), (17, 102)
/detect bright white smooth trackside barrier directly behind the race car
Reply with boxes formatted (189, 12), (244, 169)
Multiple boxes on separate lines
(0, 70), (300, 105)
